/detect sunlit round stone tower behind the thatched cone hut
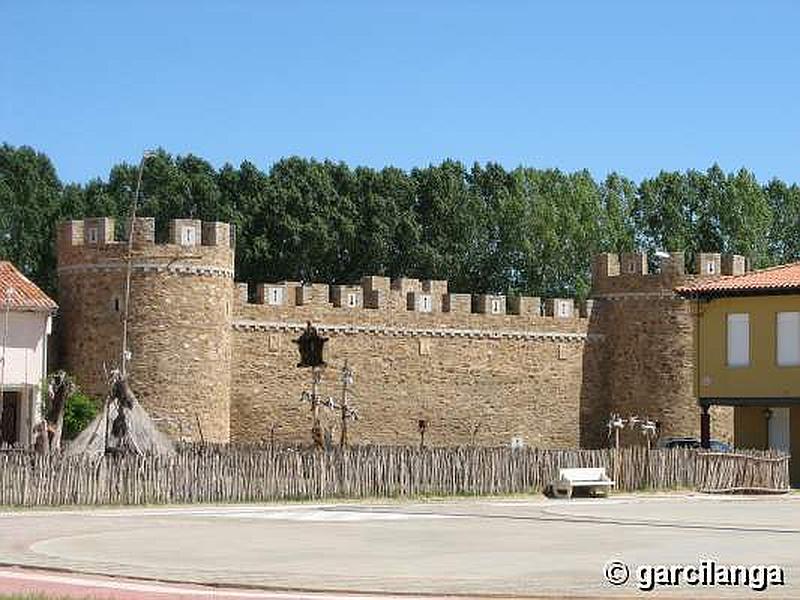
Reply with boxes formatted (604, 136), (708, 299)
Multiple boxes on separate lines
(57, 218), (234, 442)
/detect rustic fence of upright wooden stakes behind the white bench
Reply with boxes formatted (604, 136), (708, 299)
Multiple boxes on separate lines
(0, 446), (789, 506)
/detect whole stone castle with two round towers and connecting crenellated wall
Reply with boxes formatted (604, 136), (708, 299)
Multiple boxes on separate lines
(57, 218), (745, 447)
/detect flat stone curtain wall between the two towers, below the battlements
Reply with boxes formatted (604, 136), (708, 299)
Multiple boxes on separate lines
(231, 302), (604, 448)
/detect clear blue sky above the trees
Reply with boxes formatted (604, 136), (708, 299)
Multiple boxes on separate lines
(0, 0), (800, 181)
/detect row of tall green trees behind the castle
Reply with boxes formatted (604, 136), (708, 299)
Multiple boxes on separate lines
(0, 144), (800, 296)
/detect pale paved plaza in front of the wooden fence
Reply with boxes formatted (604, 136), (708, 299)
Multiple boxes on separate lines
(0, 494), (800, 598)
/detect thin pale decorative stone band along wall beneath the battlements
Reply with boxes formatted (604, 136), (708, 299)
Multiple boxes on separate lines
(233, 319), (605, 342)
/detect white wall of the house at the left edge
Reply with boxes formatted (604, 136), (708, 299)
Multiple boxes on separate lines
(0, 311), (51, 444)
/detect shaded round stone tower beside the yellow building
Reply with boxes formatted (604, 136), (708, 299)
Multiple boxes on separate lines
(592, 252), (744, 443)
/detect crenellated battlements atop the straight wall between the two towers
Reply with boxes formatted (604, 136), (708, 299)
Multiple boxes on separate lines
(237, 275), (592, 319)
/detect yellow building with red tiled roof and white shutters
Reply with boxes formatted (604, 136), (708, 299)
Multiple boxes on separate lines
(676, 263), (800, 485)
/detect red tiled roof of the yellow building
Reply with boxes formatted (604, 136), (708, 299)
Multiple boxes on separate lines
(675, 262), (800, 297)
